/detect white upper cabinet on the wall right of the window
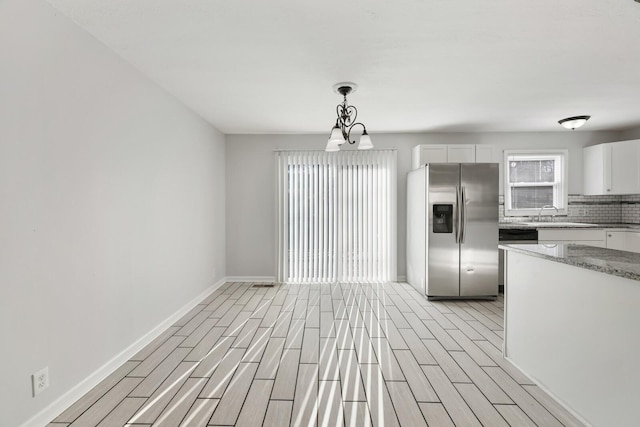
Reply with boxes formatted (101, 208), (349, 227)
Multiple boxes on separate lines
(582, 139), (640, 195)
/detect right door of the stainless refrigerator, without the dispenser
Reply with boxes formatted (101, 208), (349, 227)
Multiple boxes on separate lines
(460, 163), (498, 297)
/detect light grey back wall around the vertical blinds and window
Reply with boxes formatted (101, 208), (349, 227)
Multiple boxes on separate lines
(226, 130), (619, 276)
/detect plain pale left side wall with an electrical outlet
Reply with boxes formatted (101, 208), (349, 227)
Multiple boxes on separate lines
(0, 0), (225, 426)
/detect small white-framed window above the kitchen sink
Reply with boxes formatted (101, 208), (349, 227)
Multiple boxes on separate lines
(504, 150), (568, 216)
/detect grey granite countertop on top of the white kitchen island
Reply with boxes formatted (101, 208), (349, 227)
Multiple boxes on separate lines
(498, 243), (640, 281)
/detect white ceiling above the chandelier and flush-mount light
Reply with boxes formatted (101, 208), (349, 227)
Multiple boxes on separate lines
(48, 0), (640, 134)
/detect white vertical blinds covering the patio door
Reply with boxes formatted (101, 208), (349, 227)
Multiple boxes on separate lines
(275, 150), (396, 283)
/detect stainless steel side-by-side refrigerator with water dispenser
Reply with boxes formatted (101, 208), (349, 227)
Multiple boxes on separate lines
(407, 163), (498, 299)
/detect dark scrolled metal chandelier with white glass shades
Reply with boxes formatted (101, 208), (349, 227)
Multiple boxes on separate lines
(325, 82), (373, 151)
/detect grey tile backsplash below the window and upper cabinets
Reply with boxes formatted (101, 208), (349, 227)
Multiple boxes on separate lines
(499, 195), (640, 224)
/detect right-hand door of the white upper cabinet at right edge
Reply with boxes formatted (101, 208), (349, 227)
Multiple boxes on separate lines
(605, 141), (640, 194)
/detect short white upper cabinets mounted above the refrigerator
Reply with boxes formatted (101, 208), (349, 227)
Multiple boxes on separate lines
(411, 144), (493, 169)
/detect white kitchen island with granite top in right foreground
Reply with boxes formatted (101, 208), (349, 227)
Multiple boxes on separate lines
(500, 244), (640, 426)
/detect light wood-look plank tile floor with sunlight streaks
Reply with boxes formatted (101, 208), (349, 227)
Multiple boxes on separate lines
(49, 283), (583, 427)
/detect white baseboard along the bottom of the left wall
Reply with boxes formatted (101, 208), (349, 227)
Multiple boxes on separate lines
(21, 277), (230, 427)
